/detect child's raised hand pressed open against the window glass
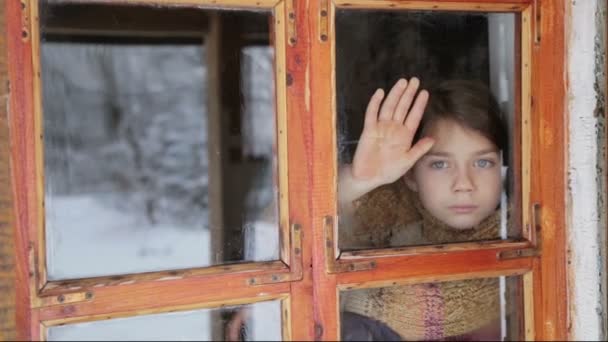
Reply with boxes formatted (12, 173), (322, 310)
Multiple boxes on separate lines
(350, 78), (434, 190)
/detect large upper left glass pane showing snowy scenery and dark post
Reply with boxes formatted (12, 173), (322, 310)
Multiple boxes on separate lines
(41, 1), (279, 280)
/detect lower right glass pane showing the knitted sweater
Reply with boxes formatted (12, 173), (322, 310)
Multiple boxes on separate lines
(340, 276), (524, 341)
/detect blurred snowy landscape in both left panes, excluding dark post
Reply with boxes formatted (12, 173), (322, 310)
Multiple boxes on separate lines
(41, 29), (281, 340)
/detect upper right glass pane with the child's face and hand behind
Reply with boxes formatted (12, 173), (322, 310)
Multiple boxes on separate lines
(336, 10), (521, 250)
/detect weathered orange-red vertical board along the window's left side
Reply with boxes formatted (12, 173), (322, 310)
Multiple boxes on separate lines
(5, 0), (38, 340)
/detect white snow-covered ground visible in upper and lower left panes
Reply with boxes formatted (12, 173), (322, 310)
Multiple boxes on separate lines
(47, 196), (281, 341)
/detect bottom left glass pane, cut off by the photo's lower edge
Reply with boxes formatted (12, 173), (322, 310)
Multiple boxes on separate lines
(48, 301), (282, 341)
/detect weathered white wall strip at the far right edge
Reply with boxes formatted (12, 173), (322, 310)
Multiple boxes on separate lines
(566, 0), (607, 340)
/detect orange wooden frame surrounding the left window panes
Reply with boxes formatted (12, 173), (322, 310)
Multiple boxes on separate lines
(6, 0), (311, 340)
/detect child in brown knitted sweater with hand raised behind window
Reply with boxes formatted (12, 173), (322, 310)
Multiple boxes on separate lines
(339, 78), (506, 340)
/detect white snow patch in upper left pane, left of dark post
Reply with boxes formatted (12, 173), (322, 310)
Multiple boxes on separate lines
(47, 196), (210, 279)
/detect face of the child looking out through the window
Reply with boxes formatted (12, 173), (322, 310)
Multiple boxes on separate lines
(406, 120), (501, 229)
